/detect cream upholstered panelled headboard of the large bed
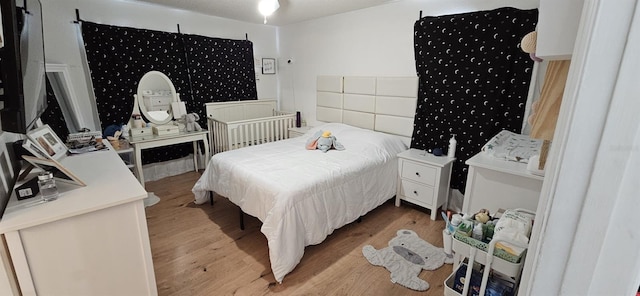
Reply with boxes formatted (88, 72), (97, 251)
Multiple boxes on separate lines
(316, 76), (418, 144)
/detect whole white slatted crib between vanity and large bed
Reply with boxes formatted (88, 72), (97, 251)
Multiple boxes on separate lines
(205, 100), (295, 155)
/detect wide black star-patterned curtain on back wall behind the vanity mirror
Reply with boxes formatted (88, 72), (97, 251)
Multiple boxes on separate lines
(82, 21), (257, 164)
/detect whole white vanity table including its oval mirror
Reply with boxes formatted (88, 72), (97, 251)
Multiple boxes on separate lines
(129, 71), (209, 186)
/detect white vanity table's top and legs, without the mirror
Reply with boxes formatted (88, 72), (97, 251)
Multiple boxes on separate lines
(129, 130), (209, 186)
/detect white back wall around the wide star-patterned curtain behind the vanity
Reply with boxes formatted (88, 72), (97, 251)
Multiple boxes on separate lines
(41, 0), (277, 130)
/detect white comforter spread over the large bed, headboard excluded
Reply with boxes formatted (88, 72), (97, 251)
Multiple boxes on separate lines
(192, 123), (407, 283)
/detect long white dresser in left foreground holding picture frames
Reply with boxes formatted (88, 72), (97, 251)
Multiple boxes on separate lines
(0, 145), (157, 295)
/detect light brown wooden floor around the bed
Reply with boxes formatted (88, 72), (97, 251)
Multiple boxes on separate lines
(146, 172), (452, 296)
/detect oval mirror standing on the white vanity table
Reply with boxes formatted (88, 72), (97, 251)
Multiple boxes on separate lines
(137, 71), (178, 124)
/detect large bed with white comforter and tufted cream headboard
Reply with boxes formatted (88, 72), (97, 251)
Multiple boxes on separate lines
(193, 76), (417, 283)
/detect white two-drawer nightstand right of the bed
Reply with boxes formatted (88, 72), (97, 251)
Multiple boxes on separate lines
(396, 149), (456, 220)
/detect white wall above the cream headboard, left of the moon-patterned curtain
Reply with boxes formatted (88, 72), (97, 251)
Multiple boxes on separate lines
(278, 0), (539, 124)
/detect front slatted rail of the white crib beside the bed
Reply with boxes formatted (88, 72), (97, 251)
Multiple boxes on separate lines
(207, 110), (295, 154)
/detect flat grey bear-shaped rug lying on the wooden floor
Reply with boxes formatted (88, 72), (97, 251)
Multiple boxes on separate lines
(362, 229), (453, 291)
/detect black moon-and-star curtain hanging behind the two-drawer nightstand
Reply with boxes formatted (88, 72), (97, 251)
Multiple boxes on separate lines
(411, 7), (538, 193)
